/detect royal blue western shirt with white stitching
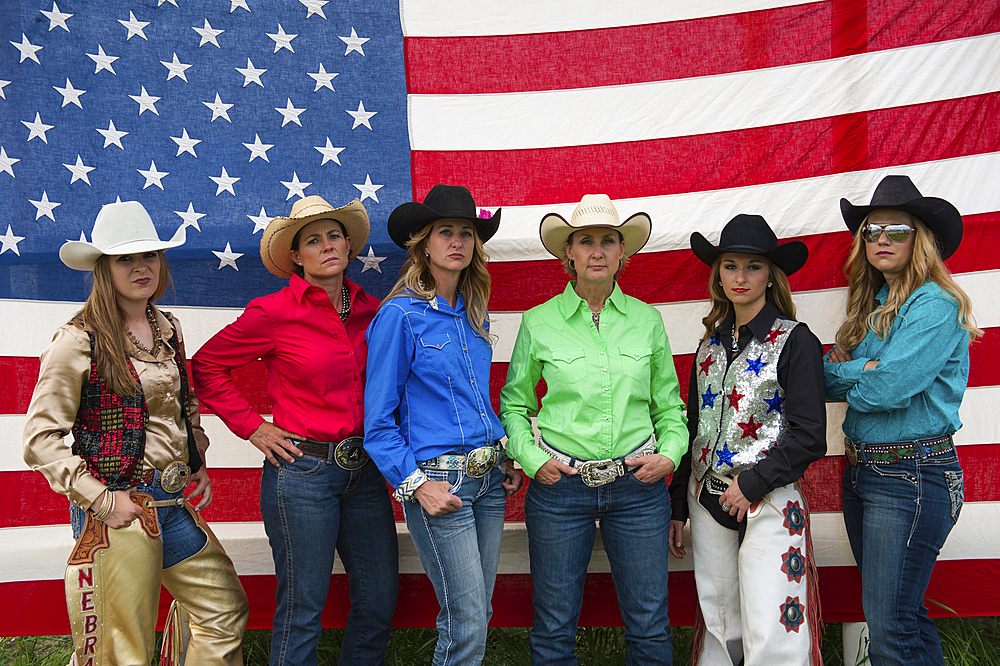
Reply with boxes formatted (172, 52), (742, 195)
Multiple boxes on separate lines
(365, 293), (504, 487)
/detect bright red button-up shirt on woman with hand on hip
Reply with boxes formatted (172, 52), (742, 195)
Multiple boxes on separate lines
(191, 275), (379, 442)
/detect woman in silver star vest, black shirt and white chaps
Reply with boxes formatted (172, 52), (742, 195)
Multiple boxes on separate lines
(670, 215), (826, 666)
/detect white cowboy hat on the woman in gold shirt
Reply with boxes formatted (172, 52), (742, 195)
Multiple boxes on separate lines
(59, 201), (185, 271)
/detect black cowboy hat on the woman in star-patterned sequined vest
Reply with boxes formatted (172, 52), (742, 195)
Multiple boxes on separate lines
(691, 213), (809, 275)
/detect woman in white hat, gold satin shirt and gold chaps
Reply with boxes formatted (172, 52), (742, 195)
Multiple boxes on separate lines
(24, 201), (248, 666)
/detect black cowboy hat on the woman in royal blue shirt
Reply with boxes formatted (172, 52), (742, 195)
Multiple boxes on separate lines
(387, 185), (500, 250)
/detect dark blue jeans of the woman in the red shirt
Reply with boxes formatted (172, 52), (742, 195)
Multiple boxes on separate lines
(260, 450), (399, 666)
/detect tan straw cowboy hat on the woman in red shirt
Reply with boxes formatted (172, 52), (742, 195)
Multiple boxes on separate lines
(260, 195), (371, 278)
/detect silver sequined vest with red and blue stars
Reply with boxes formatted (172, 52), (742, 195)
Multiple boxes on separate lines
(688, 317), (798, 481)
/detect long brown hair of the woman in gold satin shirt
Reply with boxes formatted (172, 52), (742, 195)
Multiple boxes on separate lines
(69, 250), (172, 398)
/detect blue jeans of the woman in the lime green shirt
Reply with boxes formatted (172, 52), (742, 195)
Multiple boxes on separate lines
(524, 473), (674, 666)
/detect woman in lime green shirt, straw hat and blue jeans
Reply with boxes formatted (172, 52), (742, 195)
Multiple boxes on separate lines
(500, 194), (687, 666)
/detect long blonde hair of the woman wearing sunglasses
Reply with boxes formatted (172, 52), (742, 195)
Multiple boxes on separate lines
(837, 211), (983, 350)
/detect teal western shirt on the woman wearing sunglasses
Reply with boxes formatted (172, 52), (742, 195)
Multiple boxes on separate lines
(823, 280), (969, 443)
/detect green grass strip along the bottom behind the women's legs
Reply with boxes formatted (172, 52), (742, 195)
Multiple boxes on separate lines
(0, 617), (1000, 666)
